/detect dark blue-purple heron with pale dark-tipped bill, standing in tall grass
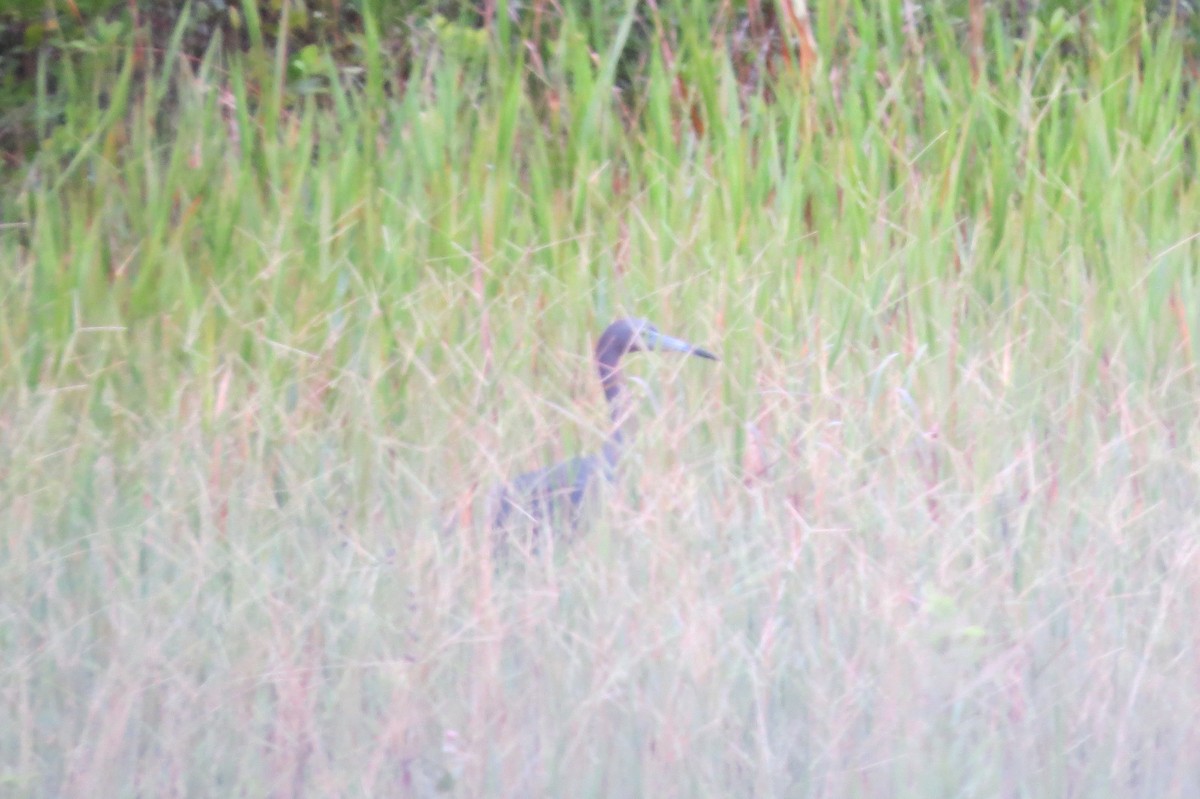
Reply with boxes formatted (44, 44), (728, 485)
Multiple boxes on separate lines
(492, 319), (719, 542)
